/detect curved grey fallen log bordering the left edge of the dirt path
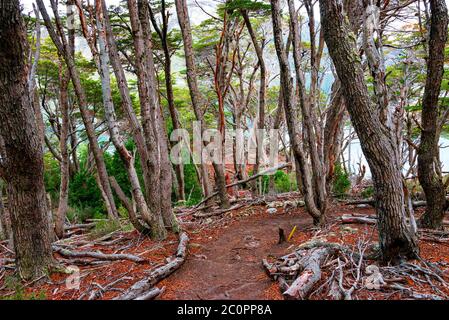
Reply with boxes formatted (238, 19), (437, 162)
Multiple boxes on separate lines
(114, 233), (189, 300)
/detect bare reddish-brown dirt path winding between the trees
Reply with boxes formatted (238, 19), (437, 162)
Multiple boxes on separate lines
(161, 212), (312, 300)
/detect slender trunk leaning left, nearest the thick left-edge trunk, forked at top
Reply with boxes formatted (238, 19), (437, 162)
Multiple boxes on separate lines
(37, 0), (118, 219)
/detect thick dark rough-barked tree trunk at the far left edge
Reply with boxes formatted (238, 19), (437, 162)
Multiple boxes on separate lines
(0, 0), (53, 280)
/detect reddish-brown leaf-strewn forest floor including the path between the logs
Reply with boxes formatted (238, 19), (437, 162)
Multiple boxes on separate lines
(0, 192), (449, 300)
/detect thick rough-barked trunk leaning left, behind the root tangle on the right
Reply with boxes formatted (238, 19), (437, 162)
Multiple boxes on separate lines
(320, 0), (419, 262)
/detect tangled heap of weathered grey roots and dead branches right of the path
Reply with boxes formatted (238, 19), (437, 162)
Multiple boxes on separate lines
(262, 237), (449, 300)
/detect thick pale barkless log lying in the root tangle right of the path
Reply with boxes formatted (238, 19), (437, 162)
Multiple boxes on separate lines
(283, 248), (333, 300)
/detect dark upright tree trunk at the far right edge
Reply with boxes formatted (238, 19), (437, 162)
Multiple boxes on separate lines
(418, 0), (448, 229)
